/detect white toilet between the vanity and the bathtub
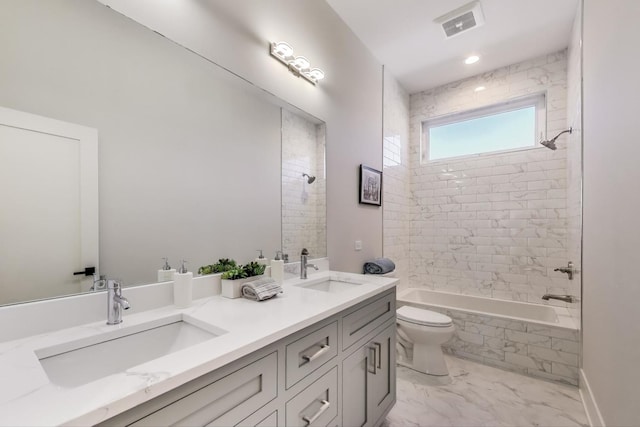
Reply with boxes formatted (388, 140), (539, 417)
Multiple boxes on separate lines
(396, 305), (455, 376)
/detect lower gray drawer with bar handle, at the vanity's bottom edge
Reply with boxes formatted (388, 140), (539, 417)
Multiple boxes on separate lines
(285, 367), (338, 427)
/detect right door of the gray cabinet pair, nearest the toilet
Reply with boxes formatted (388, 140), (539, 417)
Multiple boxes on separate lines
(367, 324), (396, 423)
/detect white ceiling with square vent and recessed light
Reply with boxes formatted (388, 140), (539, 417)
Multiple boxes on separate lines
(327, 0), (579, 93)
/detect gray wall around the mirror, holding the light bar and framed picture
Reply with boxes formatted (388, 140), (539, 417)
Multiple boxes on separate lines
(101, 0), (382, 272)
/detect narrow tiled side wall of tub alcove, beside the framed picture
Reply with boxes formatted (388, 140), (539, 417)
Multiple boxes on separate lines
(382, 70), (412, 289)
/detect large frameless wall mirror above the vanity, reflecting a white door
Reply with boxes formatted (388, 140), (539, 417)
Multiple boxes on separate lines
(0, 0), (326, 304)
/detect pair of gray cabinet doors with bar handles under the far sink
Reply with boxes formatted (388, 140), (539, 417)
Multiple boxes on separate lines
(342, 322), (396, 426)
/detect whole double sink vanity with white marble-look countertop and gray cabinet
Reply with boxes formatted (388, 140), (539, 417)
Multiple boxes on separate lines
(0, 271), (396, 426)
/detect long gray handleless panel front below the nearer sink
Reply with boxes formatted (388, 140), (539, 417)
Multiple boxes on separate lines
(132, 352), (278, 426)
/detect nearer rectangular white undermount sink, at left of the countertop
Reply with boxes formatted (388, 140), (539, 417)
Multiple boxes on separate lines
(36, 314), (226, 387)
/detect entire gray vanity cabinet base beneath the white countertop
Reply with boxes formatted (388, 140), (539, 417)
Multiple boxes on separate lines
(101, 290), (395, 427)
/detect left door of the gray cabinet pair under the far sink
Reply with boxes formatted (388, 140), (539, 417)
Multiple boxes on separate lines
(342, 345), (373, 427)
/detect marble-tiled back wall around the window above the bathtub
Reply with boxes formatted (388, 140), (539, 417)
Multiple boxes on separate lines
(409, 50), (569, 305)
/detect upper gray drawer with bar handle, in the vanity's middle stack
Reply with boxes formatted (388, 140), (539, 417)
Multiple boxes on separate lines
(286, 322), (338, 388)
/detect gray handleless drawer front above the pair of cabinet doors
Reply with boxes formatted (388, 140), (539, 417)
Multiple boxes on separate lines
(342, 292), (396, 350)
